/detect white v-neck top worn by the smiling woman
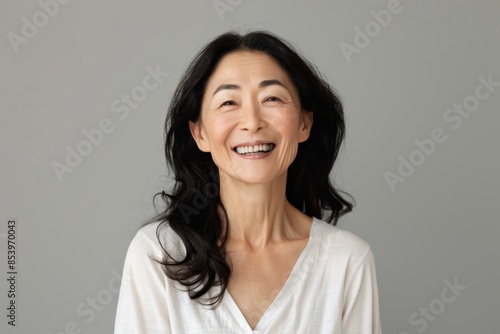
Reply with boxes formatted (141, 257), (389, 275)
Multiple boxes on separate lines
(115, 218), (381, 334)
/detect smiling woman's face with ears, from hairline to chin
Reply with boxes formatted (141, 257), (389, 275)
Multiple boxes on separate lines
(190, 52), (312, 183)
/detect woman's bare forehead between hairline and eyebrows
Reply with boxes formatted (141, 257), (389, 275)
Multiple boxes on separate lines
(208, 51), (292, 87)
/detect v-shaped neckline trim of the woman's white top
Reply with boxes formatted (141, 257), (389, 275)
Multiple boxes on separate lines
(222, 217), (319, 333)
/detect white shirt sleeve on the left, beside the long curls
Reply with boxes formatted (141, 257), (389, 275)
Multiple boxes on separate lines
(114, 231), (171, 334)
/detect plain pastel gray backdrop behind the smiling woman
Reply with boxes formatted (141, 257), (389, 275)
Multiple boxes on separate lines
(0, 0), (500, 334)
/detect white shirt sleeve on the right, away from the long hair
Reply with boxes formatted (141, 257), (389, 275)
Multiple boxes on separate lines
(342, 248), (382, 334)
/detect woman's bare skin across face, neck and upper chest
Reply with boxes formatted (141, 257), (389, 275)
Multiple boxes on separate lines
(189, 52), (313, 328)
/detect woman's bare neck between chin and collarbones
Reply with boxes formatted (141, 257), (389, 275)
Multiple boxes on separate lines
(220, 173), (310, 248)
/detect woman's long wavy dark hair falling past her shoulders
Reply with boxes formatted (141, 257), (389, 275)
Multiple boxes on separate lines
(149, 31), (354, 306)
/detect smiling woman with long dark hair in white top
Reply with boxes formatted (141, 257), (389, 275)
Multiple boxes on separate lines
(115, 32), (380, 334)
